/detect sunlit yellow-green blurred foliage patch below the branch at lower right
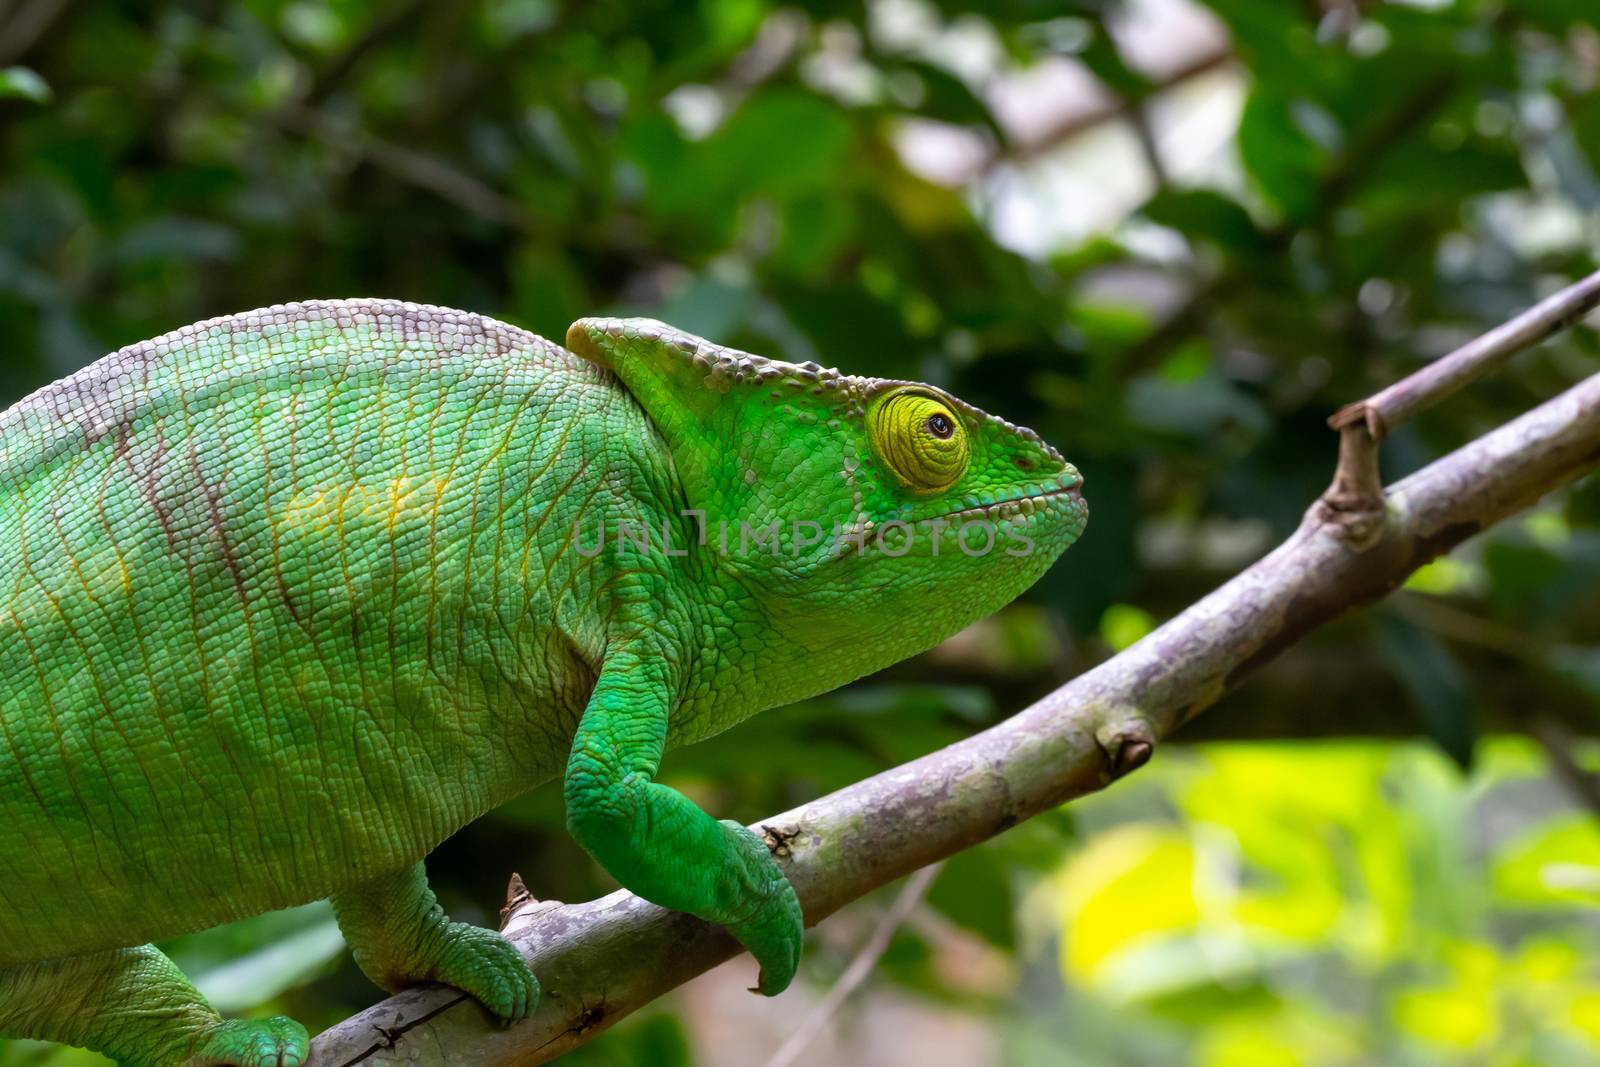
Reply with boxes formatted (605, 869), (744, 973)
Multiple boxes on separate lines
(1048, 739), (1600, 1067)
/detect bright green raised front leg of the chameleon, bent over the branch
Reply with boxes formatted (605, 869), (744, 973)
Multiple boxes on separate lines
(565, 653), (805, 997)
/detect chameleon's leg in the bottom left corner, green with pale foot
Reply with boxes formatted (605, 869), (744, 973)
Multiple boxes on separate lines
(0, 945), (310, 1067)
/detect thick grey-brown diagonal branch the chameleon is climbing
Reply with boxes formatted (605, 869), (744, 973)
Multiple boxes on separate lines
(307, 334), (1600, 1067)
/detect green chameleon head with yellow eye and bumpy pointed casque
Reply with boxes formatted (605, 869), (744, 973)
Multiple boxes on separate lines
(566, 318), (1088, 691)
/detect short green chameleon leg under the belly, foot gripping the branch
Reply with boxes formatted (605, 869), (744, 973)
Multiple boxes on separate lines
(333, 864), (539, 1021)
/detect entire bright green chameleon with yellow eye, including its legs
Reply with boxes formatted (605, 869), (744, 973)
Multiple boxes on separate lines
(0, 301), (1088, 1067)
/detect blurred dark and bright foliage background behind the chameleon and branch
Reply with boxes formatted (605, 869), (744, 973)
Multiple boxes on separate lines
(0, 0), (1600, 1067)
